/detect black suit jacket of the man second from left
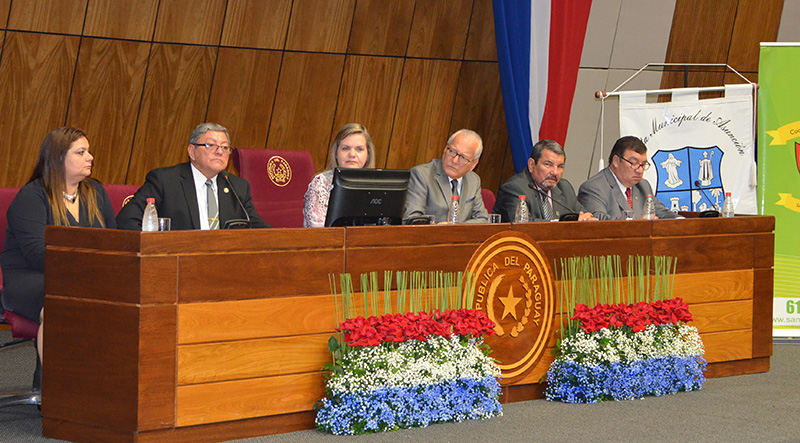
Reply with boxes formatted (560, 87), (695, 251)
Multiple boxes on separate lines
(117, 162), (269, 230)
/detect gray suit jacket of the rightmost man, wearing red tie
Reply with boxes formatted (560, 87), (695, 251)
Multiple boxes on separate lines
(578, 167), (678, 220)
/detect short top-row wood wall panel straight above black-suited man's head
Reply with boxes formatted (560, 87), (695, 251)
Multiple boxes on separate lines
(154, 0), (227, 45)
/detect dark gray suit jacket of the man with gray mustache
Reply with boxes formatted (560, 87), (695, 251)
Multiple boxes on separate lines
(492, 169), (586, 222)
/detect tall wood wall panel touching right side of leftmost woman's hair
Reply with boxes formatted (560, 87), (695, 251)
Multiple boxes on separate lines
(67, 38), (150, 183)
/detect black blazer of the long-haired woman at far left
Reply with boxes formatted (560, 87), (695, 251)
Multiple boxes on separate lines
(0, 178), (117, 323)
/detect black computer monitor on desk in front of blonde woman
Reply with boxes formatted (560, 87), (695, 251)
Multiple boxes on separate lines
(325, 168), (411, 227)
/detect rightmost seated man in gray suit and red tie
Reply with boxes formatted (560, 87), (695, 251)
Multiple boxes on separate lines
(578, 135), (678, 220)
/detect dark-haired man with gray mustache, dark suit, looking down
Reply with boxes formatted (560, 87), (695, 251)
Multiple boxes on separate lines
(493, 140), (597, 222)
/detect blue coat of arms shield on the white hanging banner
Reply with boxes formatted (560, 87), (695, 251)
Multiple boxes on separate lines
(651, 146), (725, 212)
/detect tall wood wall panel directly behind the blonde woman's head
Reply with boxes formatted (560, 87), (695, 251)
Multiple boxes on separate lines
(330, 56), (403, 168)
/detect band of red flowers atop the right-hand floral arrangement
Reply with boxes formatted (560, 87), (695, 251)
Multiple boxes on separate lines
(570, 297), (692, 333)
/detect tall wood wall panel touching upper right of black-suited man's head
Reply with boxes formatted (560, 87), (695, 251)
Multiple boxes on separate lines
(207, 48), (282, 148)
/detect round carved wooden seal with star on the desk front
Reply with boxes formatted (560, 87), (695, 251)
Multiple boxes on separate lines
(465, 231), (555, 385)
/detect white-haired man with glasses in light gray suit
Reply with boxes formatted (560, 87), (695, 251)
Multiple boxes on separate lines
(403, 129), (489, 223)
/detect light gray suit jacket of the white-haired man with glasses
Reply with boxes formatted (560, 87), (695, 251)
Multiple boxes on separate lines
(403, 158), (489, 223)
